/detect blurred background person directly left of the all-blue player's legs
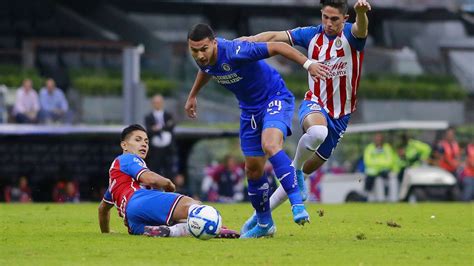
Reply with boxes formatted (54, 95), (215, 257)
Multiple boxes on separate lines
(212, 155), (245, 202)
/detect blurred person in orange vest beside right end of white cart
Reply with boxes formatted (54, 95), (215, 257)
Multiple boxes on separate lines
(435, 127), (461, 176)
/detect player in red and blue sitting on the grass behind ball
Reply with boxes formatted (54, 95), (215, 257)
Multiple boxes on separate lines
(99, 125), (239, 238)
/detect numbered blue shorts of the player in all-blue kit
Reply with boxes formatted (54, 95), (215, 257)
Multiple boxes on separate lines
(240, 94), (295, 156)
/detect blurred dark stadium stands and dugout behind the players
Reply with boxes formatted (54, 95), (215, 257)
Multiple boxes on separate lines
(0, 0), (474, 202)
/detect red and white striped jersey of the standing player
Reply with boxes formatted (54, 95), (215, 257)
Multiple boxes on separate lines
(287, 23), (366, 119)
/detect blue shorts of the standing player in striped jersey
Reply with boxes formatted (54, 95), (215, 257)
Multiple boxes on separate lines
(298, 100), (351, 161)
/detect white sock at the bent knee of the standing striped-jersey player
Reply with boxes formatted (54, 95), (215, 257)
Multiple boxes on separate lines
(290, 125), (328, 170)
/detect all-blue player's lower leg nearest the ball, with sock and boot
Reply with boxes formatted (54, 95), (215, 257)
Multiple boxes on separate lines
(241, 156), (275, 238)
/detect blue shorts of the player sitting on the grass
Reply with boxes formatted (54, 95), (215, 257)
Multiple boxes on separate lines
(125, 189), (183, 235)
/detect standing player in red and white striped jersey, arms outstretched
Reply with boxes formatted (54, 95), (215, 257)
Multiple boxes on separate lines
(239, 0), (371, 233)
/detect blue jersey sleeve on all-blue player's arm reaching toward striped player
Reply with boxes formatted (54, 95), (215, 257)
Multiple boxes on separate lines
(228, 41), (270, 62)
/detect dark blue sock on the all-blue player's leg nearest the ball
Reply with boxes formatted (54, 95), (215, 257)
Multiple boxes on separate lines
(248, 174), (272, 224)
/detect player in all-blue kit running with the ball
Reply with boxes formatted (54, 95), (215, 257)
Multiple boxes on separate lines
(185, 24), (325, 238)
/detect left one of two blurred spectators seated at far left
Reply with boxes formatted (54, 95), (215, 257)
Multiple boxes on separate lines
(13, 79), (40, 124)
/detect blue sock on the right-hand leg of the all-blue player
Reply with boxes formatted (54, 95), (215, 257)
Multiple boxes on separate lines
(266, 150), (303, 206)
